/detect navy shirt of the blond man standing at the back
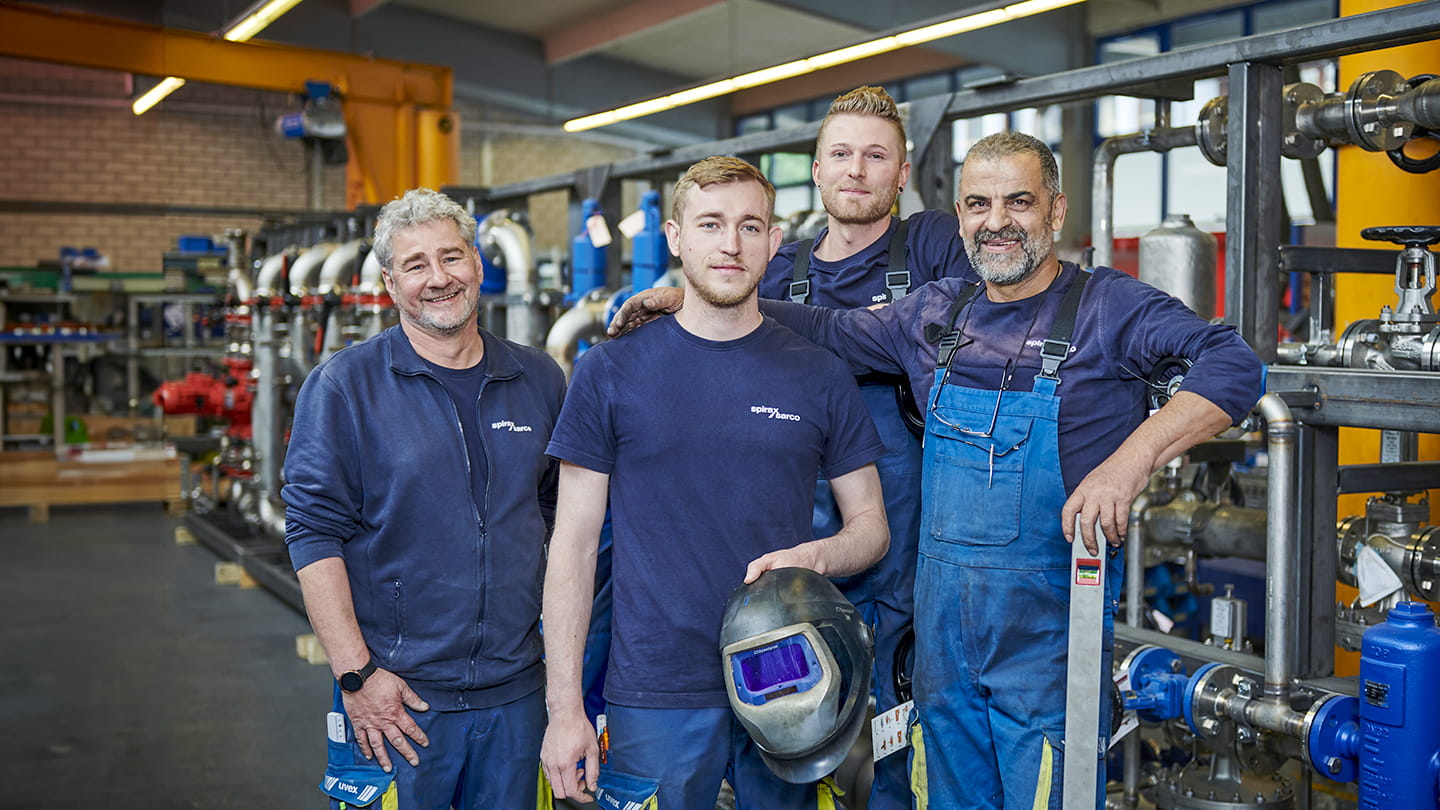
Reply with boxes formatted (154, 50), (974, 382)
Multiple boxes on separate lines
(760, 210), (979, 310)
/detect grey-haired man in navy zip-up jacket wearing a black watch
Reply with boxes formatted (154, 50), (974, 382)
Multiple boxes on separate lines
(282, 189), (564, 810)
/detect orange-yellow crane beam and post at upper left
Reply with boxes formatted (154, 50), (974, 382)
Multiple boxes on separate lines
(0, 3), (459, 206)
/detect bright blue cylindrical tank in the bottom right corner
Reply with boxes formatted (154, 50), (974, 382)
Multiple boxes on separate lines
(1358, 602), (1440, 810)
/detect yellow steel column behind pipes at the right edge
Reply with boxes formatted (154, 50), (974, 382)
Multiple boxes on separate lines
(1335, 0), (1440, 675)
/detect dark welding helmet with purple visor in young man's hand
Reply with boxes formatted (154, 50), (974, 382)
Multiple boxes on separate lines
(720, 568), (876, 784)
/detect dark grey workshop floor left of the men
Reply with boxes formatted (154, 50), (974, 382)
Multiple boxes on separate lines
(0, 504), (331, 810)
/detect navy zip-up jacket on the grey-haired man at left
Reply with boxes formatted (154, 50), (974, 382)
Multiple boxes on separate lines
(281, 321), (564, 711)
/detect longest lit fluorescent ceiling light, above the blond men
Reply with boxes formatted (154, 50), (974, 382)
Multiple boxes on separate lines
(567, 0), (1084, 133)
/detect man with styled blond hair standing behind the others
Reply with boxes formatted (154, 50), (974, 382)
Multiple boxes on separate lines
(760, 86), (978, 810)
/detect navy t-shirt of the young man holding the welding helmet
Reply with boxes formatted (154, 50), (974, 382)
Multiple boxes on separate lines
(547, 317), (884, 708)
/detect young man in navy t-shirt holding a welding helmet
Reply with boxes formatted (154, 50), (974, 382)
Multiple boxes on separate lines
(541, 157), (888, 810)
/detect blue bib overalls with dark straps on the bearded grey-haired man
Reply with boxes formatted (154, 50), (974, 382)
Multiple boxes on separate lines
(913, 274), (1119, 810)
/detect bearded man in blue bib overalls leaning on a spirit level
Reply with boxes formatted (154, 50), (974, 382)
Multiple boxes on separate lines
(618, 131), (1263, 810)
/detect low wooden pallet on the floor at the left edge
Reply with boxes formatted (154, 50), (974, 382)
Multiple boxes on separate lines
(0, 450), (183, 523)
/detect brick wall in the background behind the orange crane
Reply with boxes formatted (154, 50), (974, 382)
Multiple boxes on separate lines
(0, 58), (635, 271)
